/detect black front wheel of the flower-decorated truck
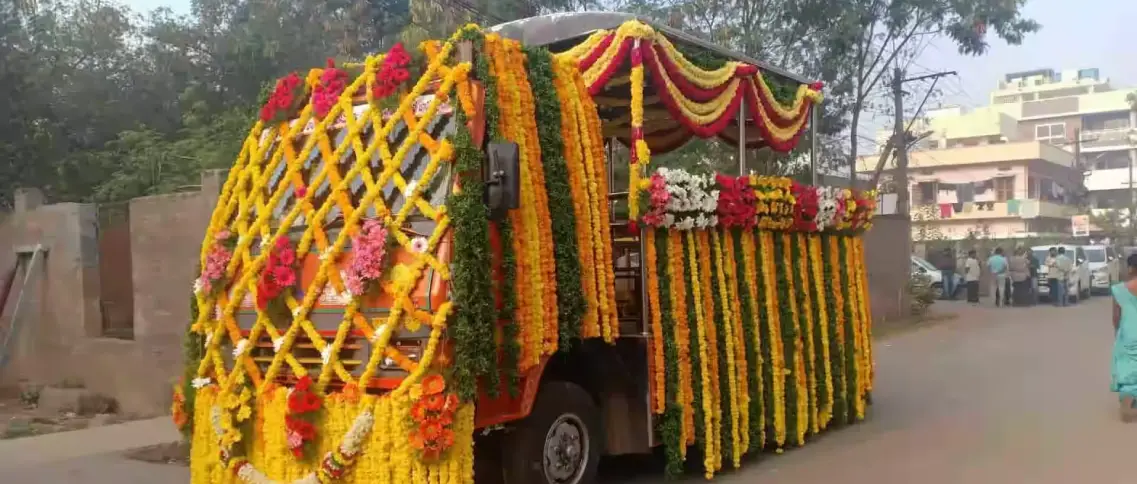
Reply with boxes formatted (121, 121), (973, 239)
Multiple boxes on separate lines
(501, 382), (600, 484)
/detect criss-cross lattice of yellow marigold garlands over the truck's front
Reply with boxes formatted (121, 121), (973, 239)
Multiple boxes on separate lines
(194, 38), (470, 415)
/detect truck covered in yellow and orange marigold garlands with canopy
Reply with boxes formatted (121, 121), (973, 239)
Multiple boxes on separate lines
(173, 14), (874, 484)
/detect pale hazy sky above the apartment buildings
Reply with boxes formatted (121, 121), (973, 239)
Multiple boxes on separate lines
(123, 0), (1137, 152)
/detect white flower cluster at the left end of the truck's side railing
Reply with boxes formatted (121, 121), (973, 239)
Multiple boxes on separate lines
(656, 168), (719, 231)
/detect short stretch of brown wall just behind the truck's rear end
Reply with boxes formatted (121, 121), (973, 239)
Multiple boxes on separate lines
(864, 215), (912, 323)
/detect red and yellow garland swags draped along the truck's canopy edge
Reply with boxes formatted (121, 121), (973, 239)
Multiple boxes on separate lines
(561, 20), (822, 232)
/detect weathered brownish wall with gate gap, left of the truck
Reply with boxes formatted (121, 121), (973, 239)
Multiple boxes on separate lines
(0, 173), (223, 415)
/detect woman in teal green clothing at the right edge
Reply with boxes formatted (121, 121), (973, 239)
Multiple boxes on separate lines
(1110, 253), (1137, 422)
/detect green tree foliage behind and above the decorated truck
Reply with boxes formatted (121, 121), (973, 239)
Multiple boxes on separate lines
(0, 0), (1037, 207)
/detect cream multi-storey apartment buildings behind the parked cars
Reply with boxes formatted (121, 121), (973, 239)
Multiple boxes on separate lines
(857, 69), (1137, 239)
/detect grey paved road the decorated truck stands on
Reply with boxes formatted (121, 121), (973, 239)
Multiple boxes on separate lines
(0, 298), (1118, 484)
